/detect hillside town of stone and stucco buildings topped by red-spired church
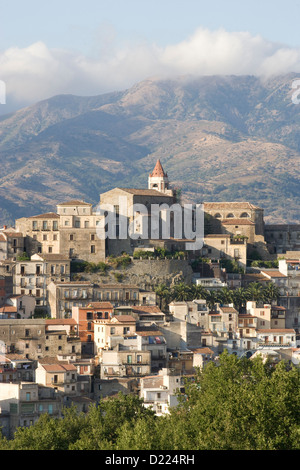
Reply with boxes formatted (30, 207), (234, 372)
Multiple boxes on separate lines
(0, 160), (300, 437)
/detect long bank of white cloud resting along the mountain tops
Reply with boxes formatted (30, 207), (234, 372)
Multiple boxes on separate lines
(0, 28), (300, 111)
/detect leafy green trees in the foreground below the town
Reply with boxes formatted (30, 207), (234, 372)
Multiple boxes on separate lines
(0, 352), (300, 450)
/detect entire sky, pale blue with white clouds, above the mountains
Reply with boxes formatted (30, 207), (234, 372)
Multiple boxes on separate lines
(0, 0), (300, 114)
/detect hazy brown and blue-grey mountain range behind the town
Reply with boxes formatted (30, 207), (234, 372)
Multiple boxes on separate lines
(0, 74), (300, 224)
